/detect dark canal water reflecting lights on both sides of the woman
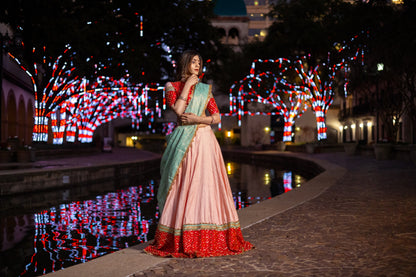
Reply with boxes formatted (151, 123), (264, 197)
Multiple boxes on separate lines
(0, 161), (306, 276)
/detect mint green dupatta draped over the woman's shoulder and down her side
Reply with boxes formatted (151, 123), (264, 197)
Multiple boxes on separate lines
(157, 83), (211, 213)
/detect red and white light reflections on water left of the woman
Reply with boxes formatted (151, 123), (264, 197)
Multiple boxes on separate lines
(16, 181), (159, 276)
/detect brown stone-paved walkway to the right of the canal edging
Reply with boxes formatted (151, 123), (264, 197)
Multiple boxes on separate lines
(130, 153), (416, 277)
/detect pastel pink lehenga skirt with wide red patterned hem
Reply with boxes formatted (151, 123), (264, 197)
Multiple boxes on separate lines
(145, 126), (253, 258)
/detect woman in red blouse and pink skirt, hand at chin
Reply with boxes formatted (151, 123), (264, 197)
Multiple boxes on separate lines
(145, 51), (253, 258)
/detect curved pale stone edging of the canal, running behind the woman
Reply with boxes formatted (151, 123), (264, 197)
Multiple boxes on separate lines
(47, 150), (347, 277)
